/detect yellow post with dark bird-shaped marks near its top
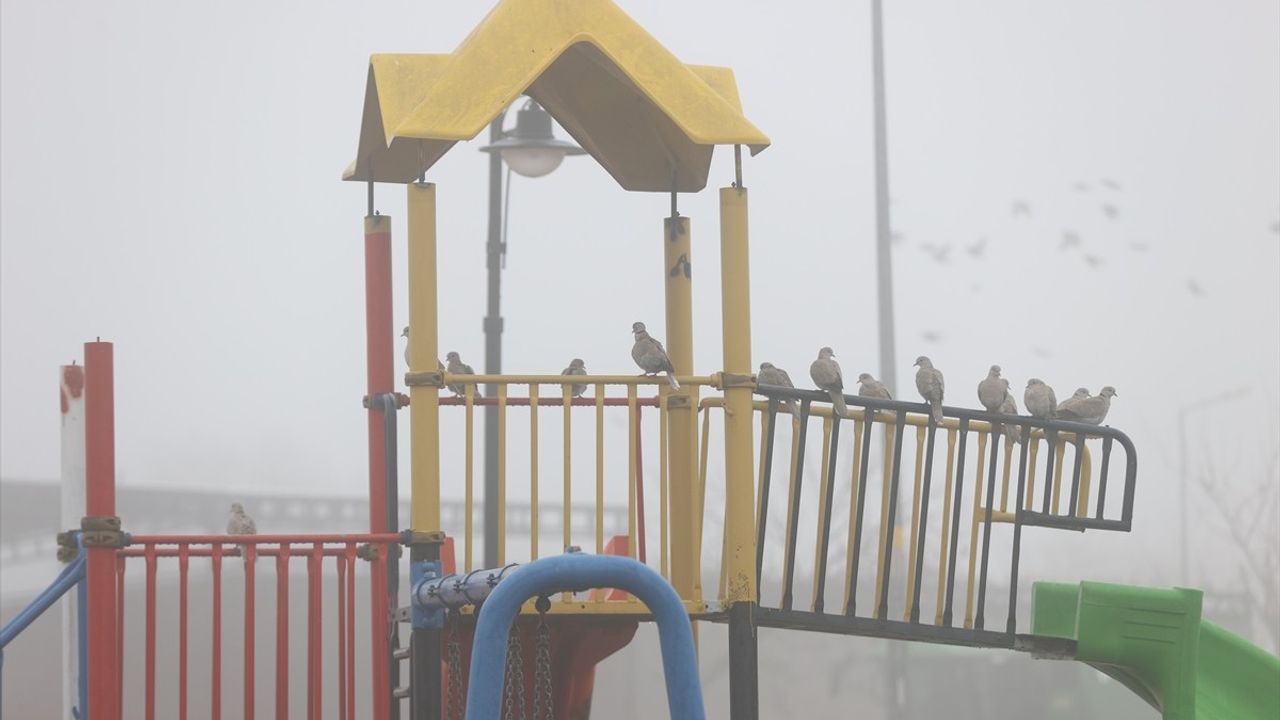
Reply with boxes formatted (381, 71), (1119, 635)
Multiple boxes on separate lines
(662, 215), (701, 600)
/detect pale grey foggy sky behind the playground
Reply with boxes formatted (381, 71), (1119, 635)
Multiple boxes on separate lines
(0, 0), (1280, 712)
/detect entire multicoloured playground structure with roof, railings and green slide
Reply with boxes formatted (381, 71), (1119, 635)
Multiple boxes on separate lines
(4, 0), (1280, 720)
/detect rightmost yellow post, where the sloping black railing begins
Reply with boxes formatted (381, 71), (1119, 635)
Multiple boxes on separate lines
(721, 186), (756, 603)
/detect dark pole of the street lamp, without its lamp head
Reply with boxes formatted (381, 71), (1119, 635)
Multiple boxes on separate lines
(484, 110), (507, 568)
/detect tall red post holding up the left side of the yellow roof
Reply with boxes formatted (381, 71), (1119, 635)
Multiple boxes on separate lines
(365, 215), (396, 720)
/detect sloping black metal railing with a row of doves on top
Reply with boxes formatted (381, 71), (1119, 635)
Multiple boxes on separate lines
(756, 386), (1137, 647)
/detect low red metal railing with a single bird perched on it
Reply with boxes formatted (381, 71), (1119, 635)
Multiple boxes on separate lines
(113, 533), (401, 720)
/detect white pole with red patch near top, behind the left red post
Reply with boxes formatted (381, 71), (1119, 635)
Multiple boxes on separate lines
(59, 364), (84, 717)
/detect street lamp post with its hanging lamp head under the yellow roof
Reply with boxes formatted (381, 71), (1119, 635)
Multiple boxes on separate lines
(480, 100), (586, 568)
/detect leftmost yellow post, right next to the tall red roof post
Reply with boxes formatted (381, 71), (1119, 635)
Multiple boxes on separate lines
(408, 183), (440, 533)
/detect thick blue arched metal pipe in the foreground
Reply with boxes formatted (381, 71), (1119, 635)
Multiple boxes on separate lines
(467, 552), (707, 720)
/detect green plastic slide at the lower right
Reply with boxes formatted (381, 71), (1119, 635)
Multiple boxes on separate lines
(1032, 583), (1280, 720)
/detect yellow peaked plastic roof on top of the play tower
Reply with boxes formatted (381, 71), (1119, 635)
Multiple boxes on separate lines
(343, 0), (769, 192)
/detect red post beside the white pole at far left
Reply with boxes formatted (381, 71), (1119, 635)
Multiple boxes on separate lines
(84, 342), (120, 720)
